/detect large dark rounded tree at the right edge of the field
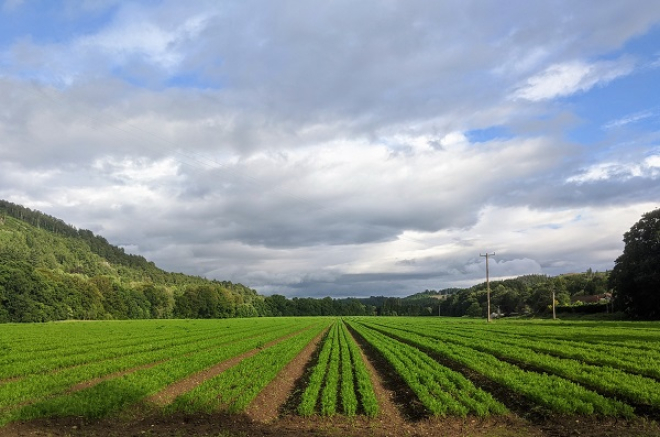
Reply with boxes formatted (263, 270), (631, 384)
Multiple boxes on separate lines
(609, 209), (660, 319)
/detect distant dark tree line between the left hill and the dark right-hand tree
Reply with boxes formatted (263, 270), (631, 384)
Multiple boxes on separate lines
(266, 271), (612, 317)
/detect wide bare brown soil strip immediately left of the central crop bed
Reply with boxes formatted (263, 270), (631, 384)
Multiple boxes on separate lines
(245, 329), (328, 423)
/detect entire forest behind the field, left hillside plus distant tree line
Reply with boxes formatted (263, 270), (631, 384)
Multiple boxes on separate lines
(0, 200), (611, 322)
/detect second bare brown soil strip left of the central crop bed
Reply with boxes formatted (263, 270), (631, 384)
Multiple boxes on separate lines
(145, 328), (309, 407)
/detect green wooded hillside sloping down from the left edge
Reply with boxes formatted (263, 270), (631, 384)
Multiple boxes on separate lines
(0, 200), (268, 322)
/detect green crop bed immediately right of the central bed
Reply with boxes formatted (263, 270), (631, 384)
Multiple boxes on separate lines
(349, 321), (507, 416)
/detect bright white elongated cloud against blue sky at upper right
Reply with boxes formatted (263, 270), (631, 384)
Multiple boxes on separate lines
(513, 59), (634, 101)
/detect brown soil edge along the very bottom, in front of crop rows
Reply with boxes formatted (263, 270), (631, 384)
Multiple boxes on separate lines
(5, 415), (660, 437)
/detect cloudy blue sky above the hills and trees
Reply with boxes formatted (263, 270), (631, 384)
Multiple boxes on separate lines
(0, 0), (660, 297)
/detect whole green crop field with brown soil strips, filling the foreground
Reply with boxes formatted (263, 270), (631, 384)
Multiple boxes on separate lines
(0, 317), (660, 436)
